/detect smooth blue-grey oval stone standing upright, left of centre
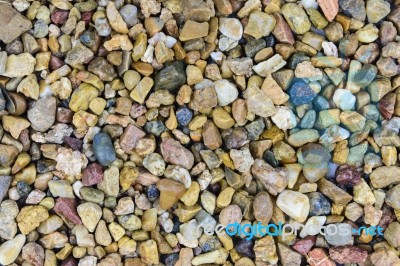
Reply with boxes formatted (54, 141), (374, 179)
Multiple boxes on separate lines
(93, 132), (117, 166)
